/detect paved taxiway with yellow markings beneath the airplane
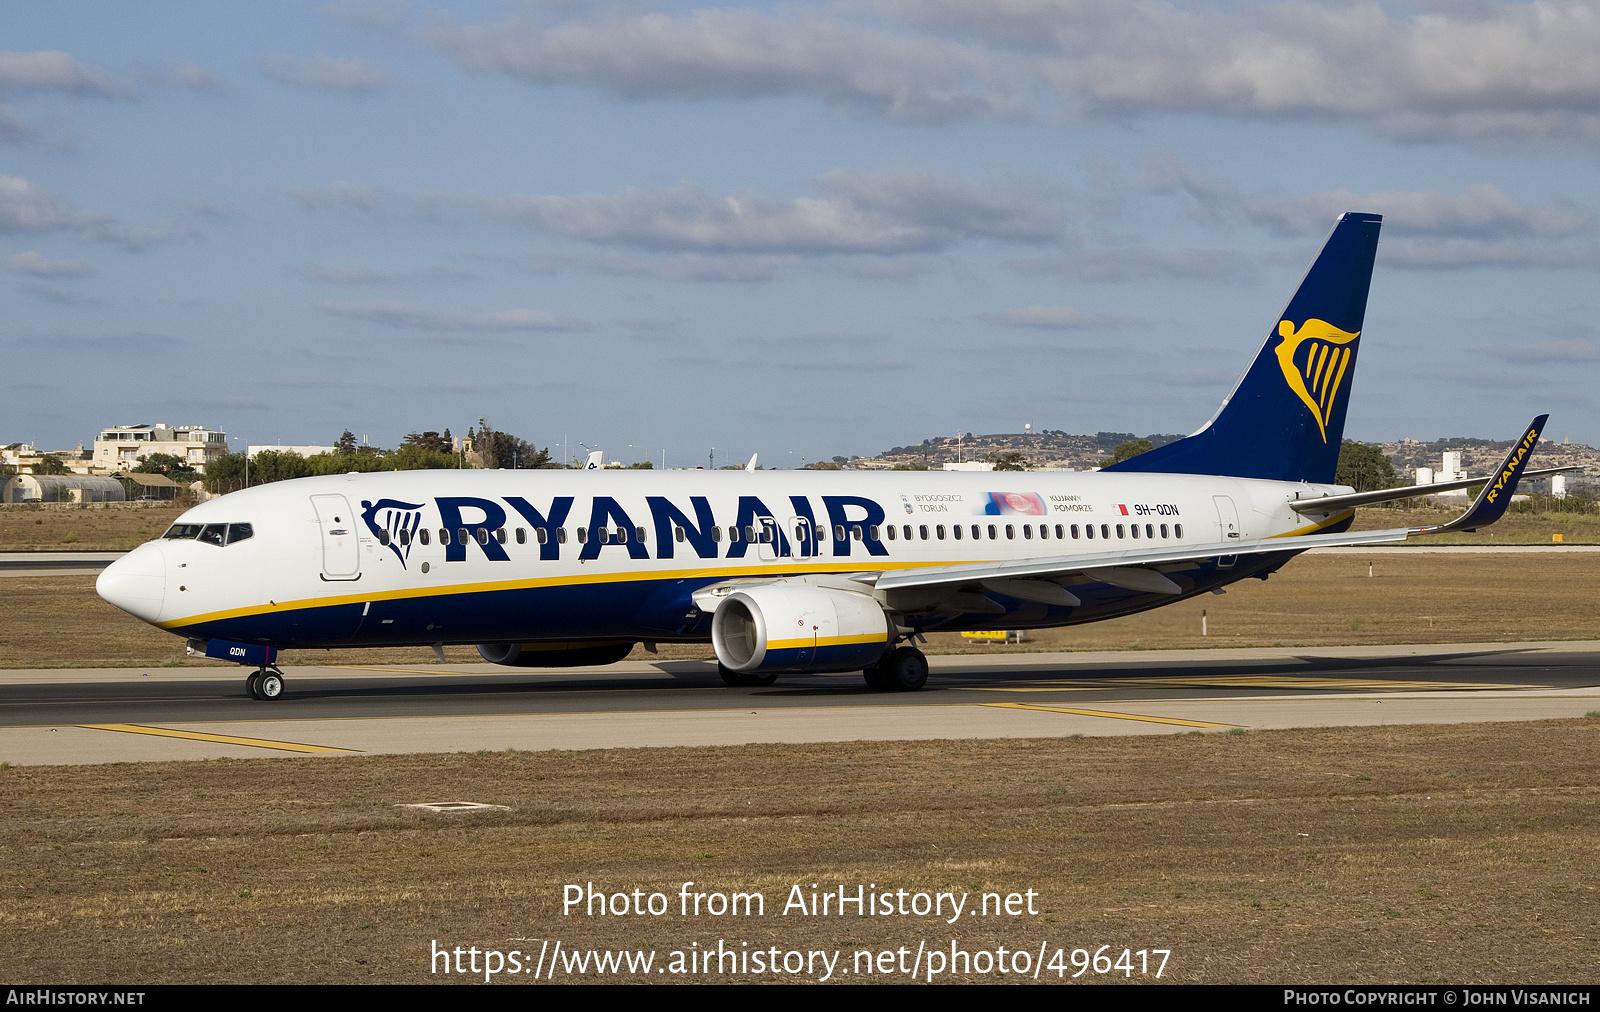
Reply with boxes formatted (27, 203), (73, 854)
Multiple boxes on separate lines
(0, 641), (1600, 764)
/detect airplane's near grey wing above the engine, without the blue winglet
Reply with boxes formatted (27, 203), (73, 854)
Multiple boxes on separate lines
(853, 527), (1413, 594)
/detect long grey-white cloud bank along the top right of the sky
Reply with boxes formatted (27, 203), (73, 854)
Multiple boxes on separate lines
(419, 0), (1600, 144)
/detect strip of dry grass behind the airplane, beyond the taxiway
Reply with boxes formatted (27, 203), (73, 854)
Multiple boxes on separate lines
(0, 549), (1600, 668)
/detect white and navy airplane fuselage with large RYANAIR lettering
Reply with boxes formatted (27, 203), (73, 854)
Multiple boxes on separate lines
(99, 471), (1350, 647)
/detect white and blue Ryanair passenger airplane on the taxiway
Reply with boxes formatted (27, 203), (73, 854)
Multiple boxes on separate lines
(96, 213), (1562, 700)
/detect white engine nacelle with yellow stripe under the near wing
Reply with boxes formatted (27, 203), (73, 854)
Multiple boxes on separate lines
(710, 584), (894, 673)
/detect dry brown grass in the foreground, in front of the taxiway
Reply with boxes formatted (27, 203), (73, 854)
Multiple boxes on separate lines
(0, 719), (1600, 985)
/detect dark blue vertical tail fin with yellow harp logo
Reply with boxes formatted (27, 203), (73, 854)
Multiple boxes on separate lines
(1106, 211), (1382, 482)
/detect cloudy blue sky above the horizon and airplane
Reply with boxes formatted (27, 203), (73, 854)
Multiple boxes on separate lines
(0, 0), (1600, 466)
